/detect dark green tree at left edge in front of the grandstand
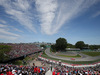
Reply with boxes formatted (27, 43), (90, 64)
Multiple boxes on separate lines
(0, 45), (11, 62)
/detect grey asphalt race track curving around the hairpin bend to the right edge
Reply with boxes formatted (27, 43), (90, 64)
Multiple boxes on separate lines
(45, 48), (100, 61)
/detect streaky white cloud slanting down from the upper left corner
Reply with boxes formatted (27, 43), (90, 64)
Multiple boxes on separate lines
(0, 0), (36, 33)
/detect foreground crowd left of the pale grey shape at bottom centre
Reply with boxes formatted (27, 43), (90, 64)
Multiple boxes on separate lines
(0, 64), (48, 75)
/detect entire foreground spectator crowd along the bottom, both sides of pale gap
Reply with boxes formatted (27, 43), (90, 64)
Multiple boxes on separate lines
(0, 64), (100, 75)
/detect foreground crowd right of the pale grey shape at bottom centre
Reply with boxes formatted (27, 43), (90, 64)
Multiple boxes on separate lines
(52, 65), (100, 75)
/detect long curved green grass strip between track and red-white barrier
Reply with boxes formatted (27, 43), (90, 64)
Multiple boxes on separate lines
(41, 52), (100, 64)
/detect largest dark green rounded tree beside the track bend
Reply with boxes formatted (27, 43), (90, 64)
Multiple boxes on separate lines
(55, 38), (67, 51)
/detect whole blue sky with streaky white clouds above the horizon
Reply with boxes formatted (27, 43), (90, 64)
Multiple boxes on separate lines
(0, 0), (100, 45)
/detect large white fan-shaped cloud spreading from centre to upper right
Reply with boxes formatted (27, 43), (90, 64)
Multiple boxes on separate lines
(35, 0), (99, 35)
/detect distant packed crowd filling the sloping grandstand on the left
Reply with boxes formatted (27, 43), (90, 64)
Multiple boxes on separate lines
(0, 43), (41, 58)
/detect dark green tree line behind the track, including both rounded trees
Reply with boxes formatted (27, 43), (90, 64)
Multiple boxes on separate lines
(51, 38), (100, 51)
